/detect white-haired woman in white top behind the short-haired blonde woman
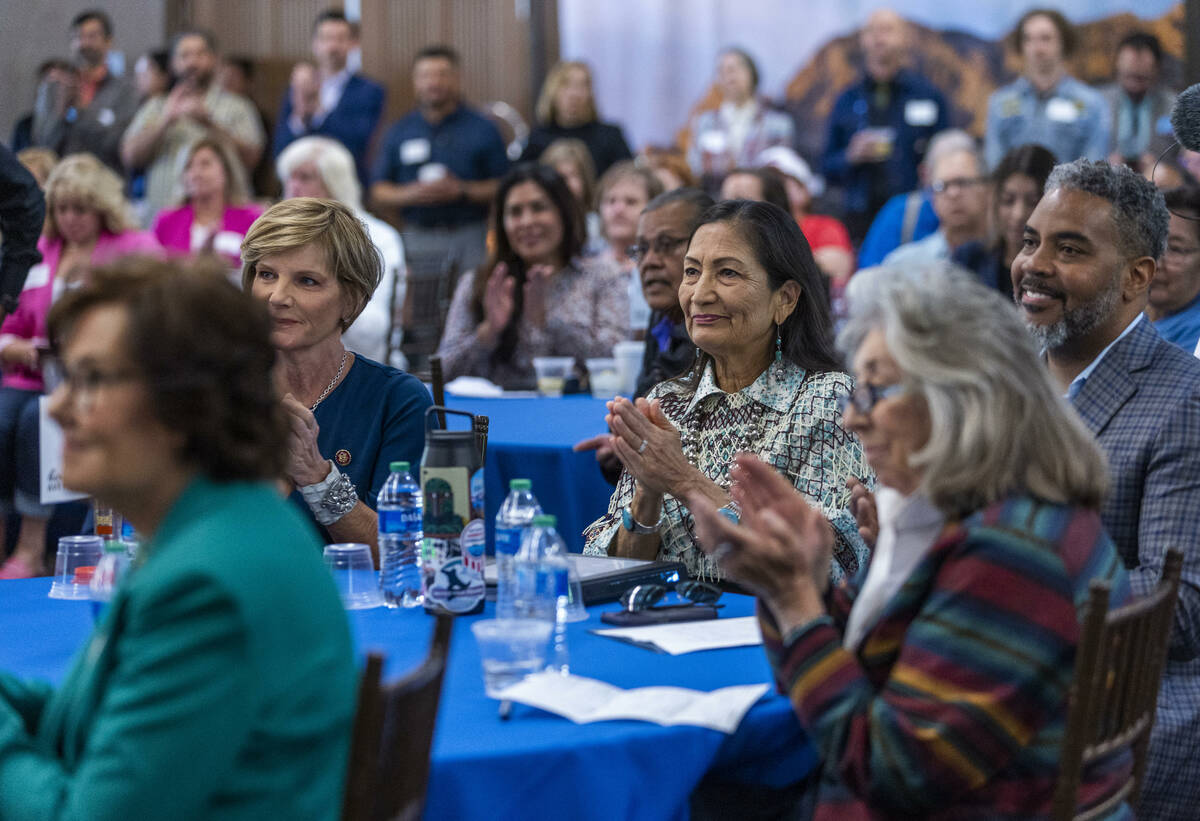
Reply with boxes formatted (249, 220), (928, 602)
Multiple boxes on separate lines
(275, 137), (407, 368)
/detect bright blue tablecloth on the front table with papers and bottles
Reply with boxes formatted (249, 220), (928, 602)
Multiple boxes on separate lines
(0, 579), (814, 821)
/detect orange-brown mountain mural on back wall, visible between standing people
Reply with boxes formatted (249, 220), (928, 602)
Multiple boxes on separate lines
(680, 2), (1183, 161)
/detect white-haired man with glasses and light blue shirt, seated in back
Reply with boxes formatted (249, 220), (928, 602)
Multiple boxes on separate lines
(883, 131), (988, 265)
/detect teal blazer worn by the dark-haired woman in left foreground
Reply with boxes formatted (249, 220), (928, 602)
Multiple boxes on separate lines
(0, 480), (356, 821)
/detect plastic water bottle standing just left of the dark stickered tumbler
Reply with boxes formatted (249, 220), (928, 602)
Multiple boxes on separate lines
(376, 462), (425, 607)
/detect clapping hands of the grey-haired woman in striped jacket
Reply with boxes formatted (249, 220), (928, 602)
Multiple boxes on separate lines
(688, 454), (833, 609)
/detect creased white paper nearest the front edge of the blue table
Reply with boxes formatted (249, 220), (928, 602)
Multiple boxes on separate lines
(500, 671), (769, 732)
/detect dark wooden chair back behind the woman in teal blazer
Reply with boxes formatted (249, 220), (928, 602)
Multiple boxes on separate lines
(342, 616), (454, 821)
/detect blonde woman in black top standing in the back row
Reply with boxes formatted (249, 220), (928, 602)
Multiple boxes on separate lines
(521, 60), (634, 174)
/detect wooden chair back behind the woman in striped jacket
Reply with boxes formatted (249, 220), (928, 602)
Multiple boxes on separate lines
(1051, 550), (1183, 821)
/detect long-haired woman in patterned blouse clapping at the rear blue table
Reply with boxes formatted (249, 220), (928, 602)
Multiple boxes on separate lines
(438, 163), (629, 388)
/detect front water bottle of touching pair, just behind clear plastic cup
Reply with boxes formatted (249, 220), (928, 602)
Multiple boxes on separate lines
(512, 515), (570, 672)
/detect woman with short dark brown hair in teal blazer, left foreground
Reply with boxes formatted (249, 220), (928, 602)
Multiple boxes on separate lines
(0, 254), (355, 821)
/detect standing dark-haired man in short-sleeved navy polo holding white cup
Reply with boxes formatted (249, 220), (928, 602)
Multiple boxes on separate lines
(371, 46), (509, 288)
